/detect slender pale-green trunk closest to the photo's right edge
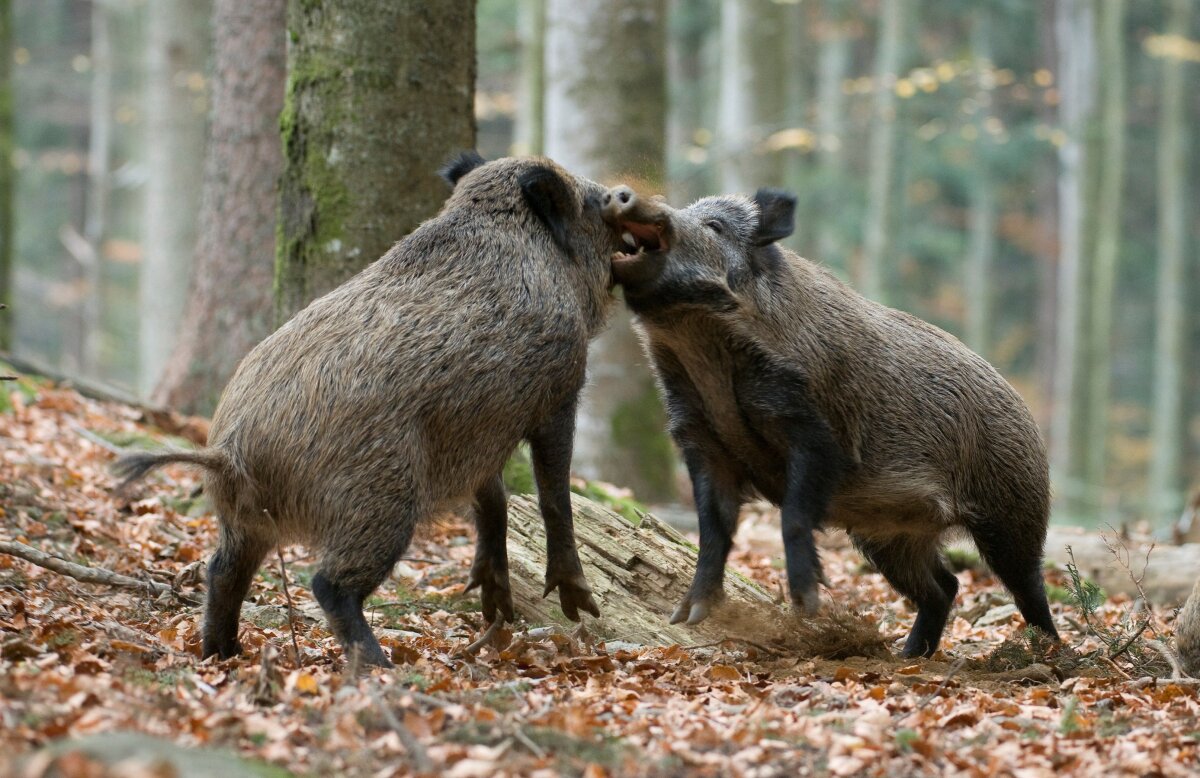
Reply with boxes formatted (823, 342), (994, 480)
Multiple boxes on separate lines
(1150, 0), (1200, 525)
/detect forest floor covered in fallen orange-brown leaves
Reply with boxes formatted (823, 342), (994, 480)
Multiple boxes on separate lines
(0, 382), (1200, 778)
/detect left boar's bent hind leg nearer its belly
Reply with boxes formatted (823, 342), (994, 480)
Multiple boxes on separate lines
(312, 501), (416, 668)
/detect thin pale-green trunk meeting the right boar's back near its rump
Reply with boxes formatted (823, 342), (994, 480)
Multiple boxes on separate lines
(962, 8), (996, 357)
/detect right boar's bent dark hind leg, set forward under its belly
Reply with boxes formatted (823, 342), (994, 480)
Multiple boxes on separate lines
(851, 535), (959, 657)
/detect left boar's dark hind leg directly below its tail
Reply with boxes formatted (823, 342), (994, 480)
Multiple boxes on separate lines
(200, 522), (271, 659)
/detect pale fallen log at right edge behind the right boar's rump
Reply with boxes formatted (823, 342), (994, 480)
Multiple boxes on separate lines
(1045, 527), (1200, 608)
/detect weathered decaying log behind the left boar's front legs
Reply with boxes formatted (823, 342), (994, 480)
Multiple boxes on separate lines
(509, 495), (773, 646)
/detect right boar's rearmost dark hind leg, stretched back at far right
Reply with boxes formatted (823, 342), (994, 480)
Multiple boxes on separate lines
(968, 521), (1058, 640)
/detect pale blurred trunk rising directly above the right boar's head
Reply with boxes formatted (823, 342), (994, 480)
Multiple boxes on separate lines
(718, 0), (790, 193)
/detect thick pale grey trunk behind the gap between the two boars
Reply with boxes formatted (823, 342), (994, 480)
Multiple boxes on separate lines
(546, 0), (676, 501)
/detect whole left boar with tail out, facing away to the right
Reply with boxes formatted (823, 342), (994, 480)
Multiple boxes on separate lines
(118, 152), (616, 665)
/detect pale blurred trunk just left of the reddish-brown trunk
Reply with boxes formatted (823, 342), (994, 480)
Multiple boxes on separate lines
(138, 0), (212, 396)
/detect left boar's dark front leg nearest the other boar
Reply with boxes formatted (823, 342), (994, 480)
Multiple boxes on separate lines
(528, 397), (600, 622)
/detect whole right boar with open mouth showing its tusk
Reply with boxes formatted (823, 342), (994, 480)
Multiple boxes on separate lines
(606, 187), (1056, 656)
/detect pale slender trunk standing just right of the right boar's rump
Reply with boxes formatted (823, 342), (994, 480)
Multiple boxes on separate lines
(1050, 0), (1096, 516)
